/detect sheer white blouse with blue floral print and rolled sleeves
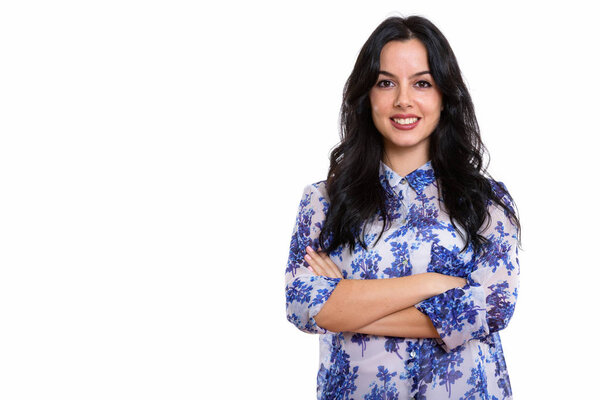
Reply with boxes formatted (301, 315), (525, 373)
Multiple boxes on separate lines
(285, 161), (519, 400)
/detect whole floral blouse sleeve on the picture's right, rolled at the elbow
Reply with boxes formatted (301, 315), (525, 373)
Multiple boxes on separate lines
(415, 183), (519, 351)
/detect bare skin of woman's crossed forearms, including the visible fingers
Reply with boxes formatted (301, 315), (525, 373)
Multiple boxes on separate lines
(305, 247), (466, 337)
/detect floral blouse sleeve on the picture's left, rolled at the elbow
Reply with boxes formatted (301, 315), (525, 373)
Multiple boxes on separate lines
(285, 182), (341, 333)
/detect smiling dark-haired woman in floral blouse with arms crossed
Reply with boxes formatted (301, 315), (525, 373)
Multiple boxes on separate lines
(286, 16), (520, 400)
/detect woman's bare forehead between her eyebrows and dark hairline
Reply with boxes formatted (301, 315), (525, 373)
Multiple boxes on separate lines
(379, 39), (429, 73)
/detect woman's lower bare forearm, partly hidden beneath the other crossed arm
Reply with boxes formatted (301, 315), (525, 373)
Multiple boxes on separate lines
(355, 307), (440, 338)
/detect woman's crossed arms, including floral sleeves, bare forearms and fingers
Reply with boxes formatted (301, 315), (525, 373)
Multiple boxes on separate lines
(286, 185), (519, 351)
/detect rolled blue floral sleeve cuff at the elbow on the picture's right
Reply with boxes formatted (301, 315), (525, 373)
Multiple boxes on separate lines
(415, 285), (489, 352)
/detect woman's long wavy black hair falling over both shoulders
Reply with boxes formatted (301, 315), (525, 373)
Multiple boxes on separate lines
(319, 16), (520, 253)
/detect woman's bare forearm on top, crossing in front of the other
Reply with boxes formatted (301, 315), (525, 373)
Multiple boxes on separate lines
(315, 273), (461, 332)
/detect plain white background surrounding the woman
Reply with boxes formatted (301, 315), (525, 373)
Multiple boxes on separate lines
(0, 0), (600, 399)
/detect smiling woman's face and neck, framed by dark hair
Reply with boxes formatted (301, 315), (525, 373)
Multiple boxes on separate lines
(369, 39), (442, 160)
